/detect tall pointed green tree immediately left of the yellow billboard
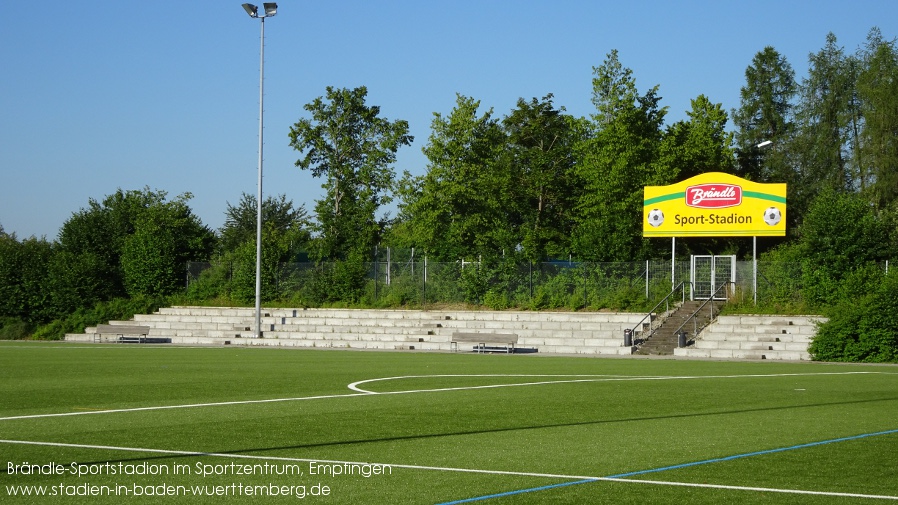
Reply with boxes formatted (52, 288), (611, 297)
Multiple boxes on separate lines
(572, 50), (667, 261)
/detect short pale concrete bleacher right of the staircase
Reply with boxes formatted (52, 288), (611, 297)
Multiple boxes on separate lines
(674, 315), (826, 361)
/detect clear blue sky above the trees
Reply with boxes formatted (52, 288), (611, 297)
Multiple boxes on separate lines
(0, 0), (898, 240)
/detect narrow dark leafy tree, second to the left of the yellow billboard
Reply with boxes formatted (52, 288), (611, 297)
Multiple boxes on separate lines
(502, 94), (577, 260)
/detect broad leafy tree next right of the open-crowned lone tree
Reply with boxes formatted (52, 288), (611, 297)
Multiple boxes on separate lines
(400, 95), (518, 260)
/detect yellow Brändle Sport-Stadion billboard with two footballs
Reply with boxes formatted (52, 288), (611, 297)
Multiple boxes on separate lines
(642, 172), (786, 237)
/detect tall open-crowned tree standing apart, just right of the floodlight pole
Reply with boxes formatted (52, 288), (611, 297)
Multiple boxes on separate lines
(289, 86), (414, 259)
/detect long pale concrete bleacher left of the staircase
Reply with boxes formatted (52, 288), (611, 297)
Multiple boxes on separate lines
(66, 307), (644, 355)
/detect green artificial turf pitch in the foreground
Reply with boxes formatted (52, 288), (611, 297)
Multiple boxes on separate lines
(0, 342), (898, 504)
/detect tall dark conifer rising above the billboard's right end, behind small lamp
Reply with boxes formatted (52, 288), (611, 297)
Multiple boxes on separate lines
(732, 46), (798, 183)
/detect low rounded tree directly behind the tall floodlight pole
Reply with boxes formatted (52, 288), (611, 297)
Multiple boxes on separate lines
(219, 193), (309, 261)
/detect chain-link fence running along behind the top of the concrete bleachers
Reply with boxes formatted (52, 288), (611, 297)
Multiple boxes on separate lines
(187, 249), (888, 310)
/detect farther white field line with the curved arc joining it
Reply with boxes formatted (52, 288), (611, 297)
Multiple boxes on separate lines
(0, 372), (885, 421)
